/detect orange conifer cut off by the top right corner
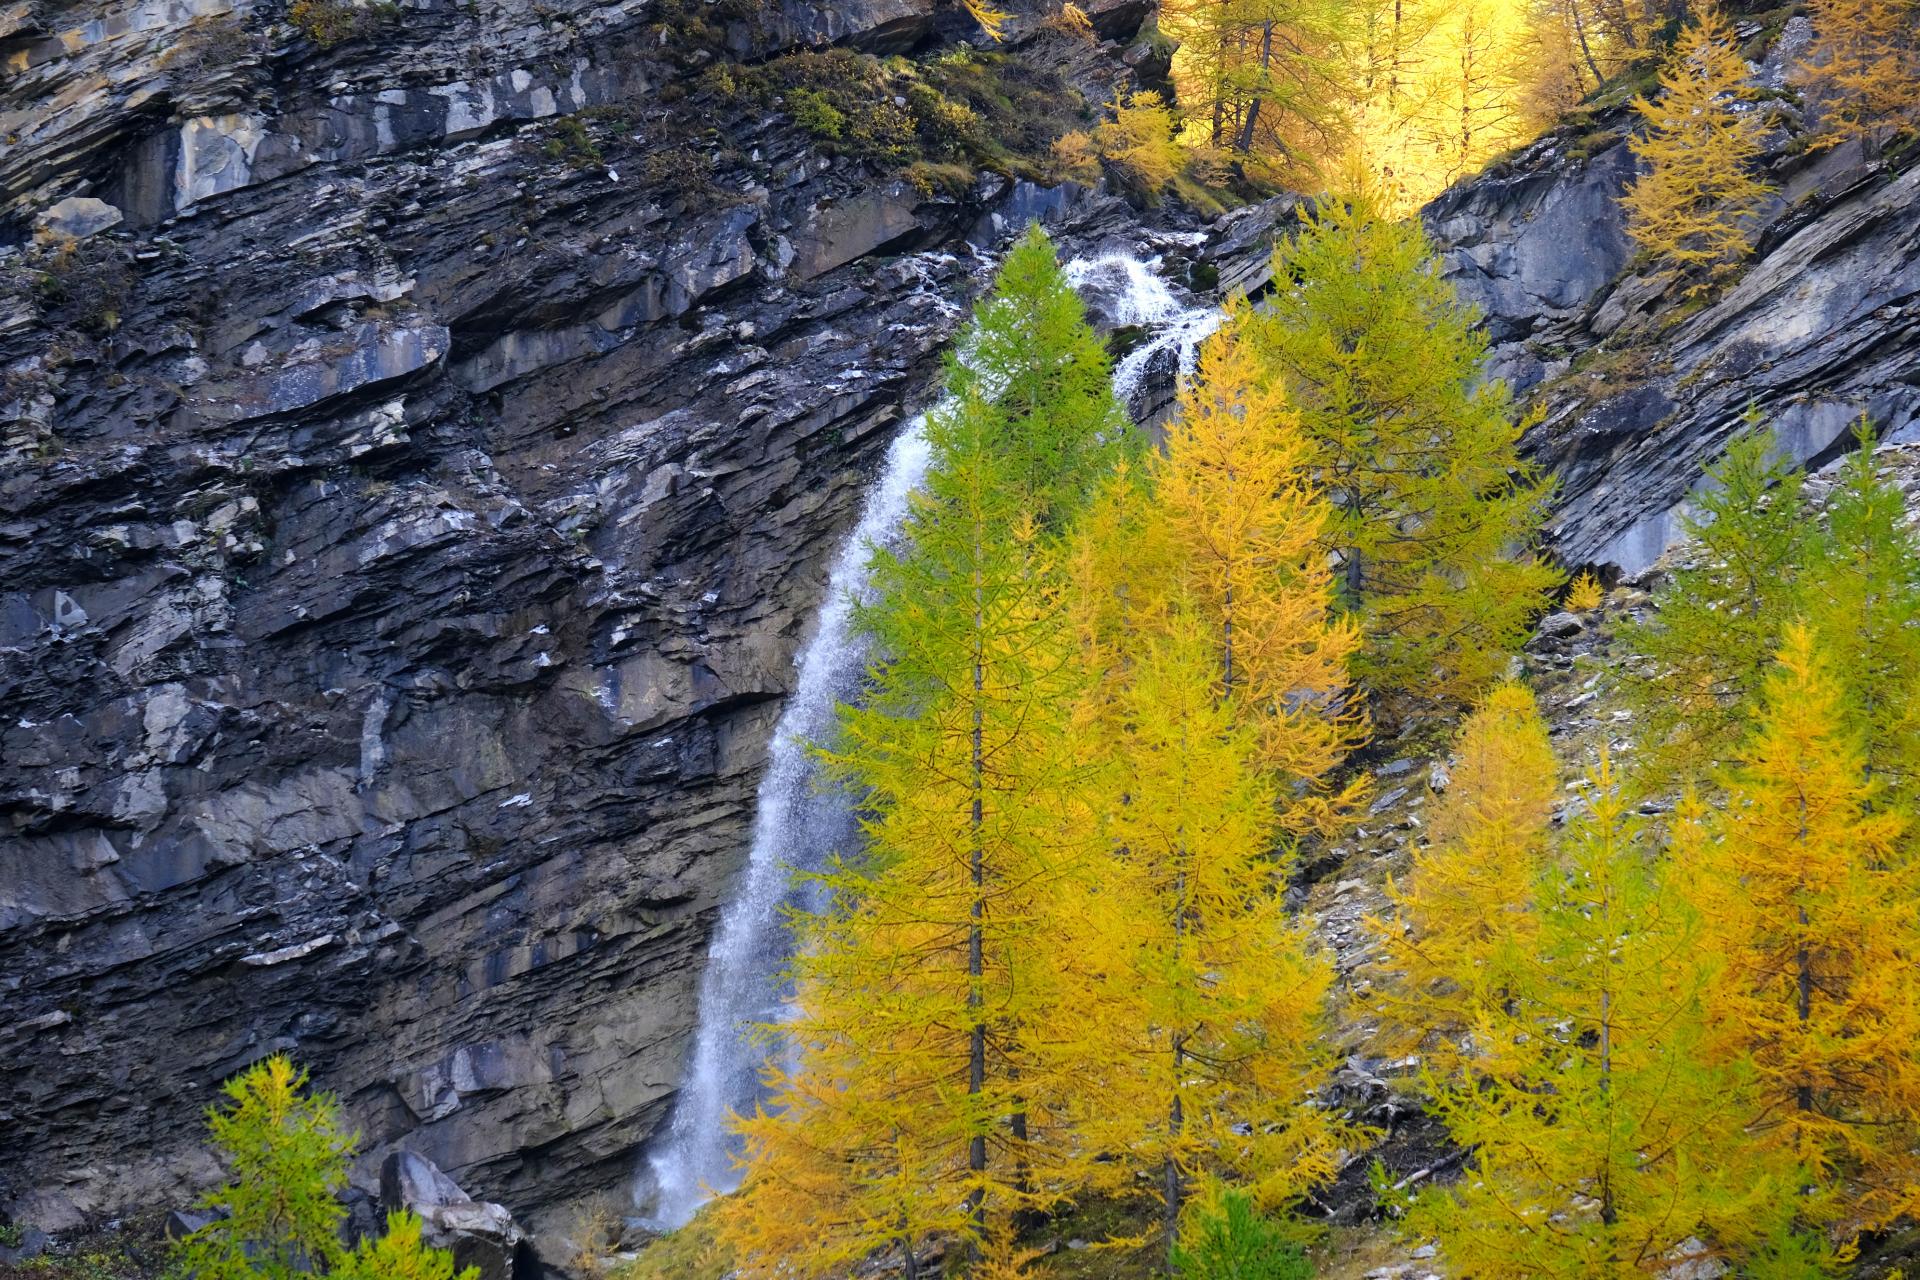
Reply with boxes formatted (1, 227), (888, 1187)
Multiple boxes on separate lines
(1807, 0), (1920, 142)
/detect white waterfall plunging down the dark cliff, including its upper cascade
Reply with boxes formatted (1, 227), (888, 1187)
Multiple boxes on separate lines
(637, 253), (1219, 1228)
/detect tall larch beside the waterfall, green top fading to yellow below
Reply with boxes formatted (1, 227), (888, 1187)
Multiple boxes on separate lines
(722, 228), (1129, 1276)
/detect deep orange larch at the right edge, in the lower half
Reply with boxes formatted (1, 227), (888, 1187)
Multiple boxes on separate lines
(1682, 624), (1920, 1222)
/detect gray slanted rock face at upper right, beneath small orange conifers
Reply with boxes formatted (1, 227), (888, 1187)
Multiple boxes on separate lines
(1425, 119), (1920, 572)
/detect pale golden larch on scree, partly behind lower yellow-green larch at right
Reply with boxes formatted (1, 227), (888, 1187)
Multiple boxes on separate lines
(1367, 683), (1559, 1057)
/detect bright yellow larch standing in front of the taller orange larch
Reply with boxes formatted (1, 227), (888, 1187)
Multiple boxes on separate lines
(1068, 610), (1346, 1247)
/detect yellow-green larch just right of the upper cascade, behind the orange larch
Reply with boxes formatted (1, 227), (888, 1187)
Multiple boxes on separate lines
(1258, 196), (1559, 702)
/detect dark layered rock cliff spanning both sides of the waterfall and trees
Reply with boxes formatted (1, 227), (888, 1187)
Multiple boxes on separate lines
(0, 0), (1920, 1258)
